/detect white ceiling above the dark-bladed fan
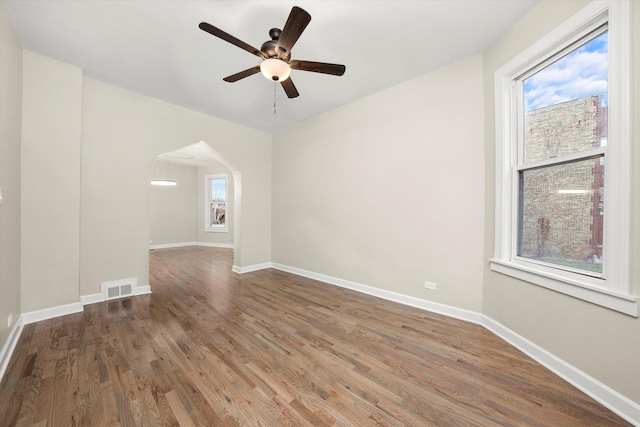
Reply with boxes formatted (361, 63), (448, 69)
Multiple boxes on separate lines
(5, 0), (539, 132)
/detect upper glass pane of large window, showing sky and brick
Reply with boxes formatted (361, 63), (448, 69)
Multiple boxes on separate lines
(523, 31), (608, 163)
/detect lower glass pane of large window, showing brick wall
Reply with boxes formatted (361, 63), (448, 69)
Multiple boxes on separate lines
(518, 157), (604, 273)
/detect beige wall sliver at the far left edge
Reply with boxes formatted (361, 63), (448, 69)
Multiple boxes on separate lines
(0, 1), (22, 349)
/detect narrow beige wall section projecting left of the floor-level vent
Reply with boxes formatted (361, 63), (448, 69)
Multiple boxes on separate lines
(21, 51), (82, 312)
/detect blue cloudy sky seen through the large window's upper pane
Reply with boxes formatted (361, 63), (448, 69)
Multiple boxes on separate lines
(524, 31), (609, 111)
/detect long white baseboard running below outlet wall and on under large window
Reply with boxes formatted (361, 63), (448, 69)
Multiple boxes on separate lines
(268, 263), (640, 427)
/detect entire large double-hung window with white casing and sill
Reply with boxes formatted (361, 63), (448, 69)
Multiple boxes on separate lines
(491, 1), (638, 316)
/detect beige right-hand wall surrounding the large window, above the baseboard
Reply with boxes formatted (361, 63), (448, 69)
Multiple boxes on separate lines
(483, 1), (640, 403)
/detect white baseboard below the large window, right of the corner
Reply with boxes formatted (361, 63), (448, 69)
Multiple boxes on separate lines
(482, 315), (640, 426)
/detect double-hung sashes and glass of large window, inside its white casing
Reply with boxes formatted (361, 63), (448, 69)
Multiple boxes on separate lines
(514, 30), (608, 277)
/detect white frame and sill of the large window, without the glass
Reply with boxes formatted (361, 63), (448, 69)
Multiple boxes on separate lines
(490, 0), (638, 317)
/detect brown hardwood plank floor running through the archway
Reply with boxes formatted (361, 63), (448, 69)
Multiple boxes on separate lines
(0, 247), (629, 427)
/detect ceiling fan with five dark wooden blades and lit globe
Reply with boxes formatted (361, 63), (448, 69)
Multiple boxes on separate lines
(199, 6), (346, 98)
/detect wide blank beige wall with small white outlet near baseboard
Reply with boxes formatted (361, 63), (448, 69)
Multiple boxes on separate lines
(273, 56), (484, 311)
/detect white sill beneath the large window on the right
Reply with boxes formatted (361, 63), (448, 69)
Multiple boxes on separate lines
(489, 258), (638, 317)
